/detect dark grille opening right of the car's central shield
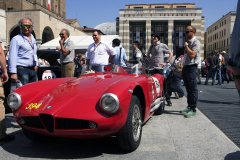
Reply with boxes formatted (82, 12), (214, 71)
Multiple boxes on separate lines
(56, 118), (90, 129)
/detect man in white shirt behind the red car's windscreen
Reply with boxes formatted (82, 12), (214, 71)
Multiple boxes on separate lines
(86, 30), (116, 72)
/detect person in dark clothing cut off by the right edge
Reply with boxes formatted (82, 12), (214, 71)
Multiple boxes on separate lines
(229, 0), (240, 104)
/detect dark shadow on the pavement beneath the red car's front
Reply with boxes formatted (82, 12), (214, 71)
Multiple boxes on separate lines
(1, 115), (132, 159)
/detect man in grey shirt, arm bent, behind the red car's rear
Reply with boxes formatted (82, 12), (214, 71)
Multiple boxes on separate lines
(147, 33), (173, 74)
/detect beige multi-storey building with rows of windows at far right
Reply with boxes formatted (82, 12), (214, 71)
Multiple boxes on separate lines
(206, 11), (236, 57)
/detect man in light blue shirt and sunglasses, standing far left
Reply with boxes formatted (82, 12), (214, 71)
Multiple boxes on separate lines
(8, 18), (38, 85)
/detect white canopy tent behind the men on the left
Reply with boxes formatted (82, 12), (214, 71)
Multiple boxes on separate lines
(39, 35), (119, 50)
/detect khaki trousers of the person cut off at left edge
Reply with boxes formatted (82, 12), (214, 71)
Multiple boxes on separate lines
(0, 79), (6, 139)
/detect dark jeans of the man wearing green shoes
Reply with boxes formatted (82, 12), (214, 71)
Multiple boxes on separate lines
(182, 65), (198, 112)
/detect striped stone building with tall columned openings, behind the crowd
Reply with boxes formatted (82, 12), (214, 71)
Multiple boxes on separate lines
(116, 3), (205, 58)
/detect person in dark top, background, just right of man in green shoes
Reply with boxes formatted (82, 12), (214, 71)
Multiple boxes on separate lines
(205, 51), (218, 85)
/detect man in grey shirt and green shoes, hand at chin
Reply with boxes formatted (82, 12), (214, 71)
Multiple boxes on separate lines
(180, 26), (201, 118)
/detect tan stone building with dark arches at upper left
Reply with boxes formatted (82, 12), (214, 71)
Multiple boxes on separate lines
(0, 0), (86, 46)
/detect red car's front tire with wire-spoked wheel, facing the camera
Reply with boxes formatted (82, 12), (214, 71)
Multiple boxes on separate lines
(117, 95), (142, 151)
